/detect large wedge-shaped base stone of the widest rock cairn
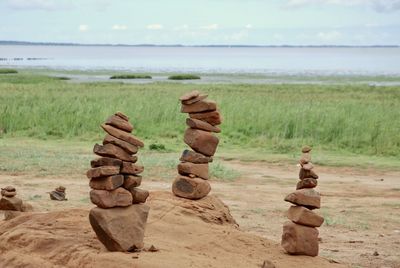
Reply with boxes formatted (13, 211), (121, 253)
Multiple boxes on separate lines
(89, 204), (150, 252)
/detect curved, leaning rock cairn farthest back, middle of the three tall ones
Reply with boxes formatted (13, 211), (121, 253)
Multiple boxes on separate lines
(172, 90), (222, 199)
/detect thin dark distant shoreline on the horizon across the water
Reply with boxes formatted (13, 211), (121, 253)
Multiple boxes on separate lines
(0, 41), (400, 48)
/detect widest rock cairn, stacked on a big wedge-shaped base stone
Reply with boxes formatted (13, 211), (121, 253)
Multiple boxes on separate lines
(86, 112), (149, 251)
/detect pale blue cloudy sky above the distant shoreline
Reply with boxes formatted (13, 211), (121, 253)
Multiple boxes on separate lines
(0, 0), (400, 45)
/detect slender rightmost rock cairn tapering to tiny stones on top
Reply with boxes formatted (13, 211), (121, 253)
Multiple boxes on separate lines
(281, 146), (324, 256)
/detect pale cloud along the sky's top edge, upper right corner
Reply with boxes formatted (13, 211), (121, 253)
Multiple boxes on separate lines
(284, 0), (400, 12)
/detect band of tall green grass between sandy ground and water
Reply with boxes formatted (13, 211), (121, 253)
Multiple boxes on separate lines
(0, 74), (400, 169)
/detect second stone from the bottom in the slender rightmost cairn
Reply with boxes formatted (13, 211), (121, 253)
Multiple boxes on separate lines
(287, 206), (324, 227)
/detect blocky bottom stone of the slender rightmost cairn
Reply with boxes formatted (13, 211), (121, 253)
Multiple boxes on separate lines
(281, 222), (318, 257)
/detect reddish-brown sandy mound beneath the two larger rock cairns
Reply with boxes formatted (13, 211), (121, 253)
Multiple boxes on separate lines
(0, 192), (340, 268)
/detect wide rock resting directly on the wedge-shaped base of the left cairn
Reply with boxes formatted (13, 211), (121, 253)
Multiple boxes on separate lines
(90, 187), (132, 208)
